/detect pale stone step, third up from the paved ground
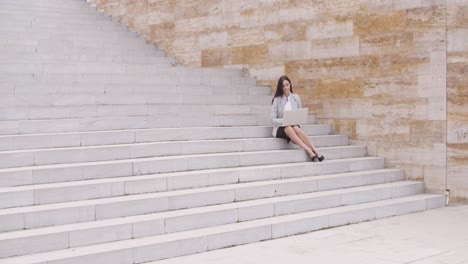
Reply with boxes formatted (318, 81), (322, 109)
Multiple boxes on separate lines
(0, 170), (404, 231)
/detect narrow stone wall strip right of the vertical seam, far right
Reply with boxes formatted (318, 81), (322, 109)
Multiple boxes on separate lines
(447, 0), (468, 203)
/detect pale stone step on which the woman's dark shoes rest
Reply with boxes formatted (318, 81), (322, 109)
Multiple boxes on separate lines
(0, 146), (367, 187)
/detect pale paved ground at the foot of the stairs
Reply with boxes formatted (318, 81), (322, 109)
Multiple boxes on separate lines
(157, 206), (468, 264)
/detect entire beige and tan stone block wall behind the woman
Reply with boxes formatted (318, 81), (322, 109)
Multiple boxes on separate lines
(96, 0), (468, 201)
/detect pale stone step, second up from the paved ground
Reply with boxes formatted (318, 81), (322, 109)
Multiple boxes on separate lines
(0, 179), (423, 258)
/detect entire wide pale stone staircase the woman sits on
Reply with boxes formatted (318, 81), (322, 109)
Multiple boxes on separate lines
(0, 0), (445, 264)
